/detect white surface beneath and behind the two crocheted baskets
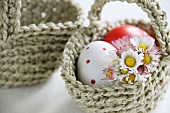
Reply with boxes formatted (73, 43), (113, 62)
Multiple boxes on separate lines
(0, 0), (170, 113)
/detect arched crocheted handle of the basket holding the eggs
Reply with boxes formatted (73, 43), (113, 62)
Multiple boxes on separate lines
(88, 0), (170, 56)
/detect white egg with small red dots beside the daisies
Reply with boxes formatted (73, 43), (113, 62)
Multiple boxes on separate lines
(77, 41), (115, 86)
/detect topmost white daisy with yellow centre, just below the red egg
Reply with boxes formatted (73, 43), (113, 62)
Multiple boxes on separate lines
(130, 36), (155, 52)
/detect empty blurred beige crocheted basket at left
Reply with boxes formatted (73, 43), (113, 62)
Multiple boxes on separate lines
(0, 0), (83, 87)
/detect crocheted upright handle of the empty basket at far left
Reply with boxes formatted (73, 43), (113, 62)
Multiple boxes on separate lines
(0, 0), (21, 42)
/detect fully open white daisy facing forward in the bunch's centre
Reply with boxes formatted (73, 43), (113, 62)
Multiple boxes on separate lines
(120, 49), (143, 72)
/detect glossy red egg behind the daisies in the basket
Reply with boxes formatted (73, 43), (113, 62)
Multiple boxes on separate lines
(104, 25), (149, 43)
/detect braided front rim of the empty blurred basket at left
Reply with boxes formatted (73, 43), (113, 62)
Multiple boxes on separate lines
(14, 0), (85, 36)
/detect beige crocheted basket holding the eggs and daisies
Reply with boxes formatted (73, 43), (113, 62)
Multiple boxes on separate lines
(62, 0), (170, 113)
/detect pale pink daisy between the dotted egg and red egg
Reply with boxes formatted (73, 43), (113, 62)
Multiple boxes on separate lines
(112, 36), (133, 55)
